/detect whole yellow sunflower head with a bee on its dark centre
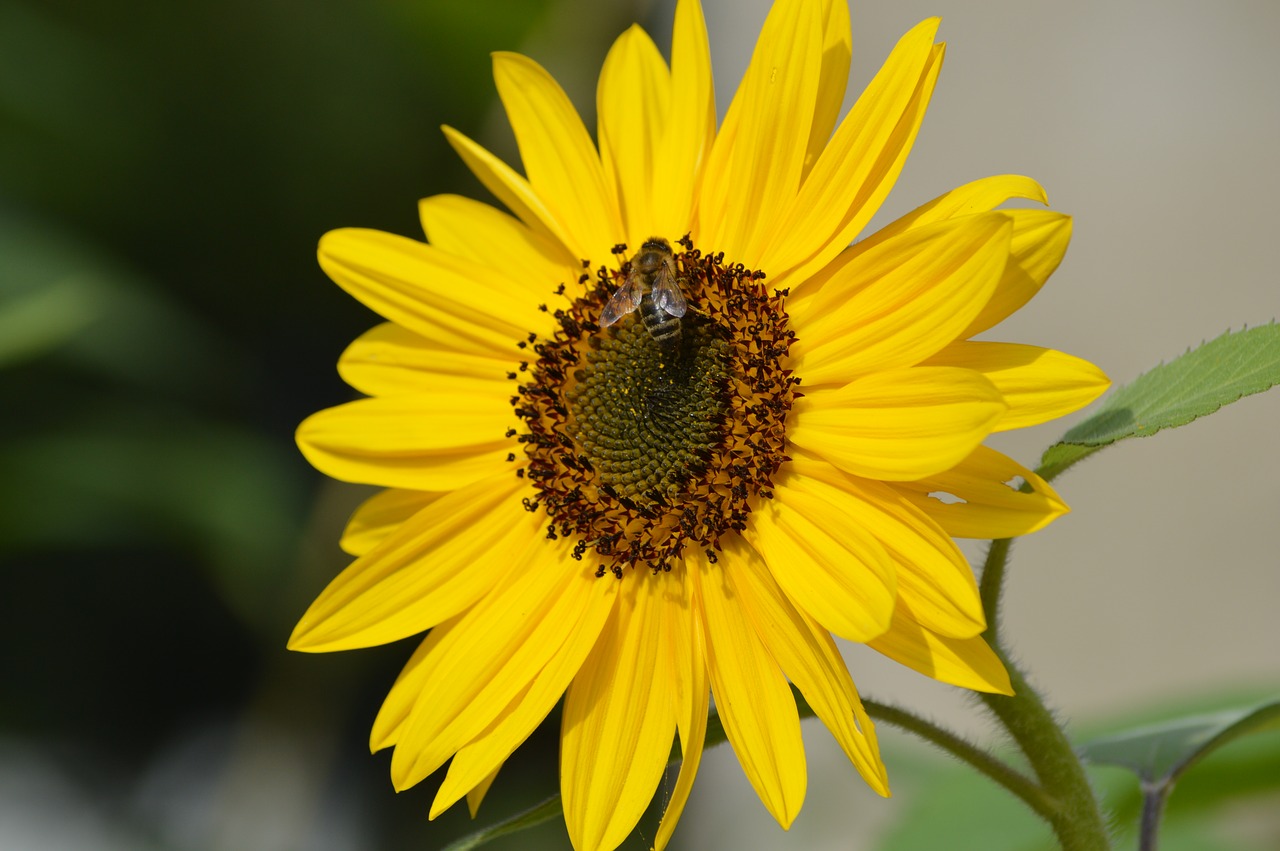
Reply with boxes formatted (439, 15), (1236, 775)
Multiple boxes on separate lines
(291, 0), (1107, 851)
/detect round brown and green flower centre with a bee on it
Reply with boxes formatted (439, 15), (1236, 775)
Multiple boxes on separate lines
(509, 237), (799, 577)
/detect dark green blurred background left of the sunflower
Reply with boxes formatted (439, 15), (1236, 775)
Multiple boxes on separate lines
(0, 0), (669, 850)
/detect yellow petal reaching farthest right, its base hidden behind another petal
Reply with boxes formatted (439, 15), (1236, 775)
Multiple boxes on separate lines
(927, 342), (1111, 431)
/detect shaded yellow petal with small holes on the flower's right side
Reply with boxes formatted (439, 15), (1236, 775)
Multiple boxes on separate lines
(896, 447), (1070, 537)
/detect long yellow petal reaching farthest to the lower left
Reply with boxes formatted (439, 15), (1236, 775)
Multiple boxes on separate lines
(289, 473), (543, 653)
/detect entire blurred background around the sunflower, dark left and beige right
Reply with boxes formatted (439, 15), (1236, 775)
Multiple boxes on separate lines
(0, 0), (1280, 851)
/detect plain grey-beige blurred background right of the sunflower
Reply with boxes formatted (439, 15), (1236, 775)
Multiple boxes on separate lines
(694, 0), (1280, 850)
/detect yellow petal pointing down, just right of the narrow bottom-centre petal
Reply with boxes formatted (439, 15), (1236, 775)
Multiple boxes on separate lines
(685, 550), (808, 828)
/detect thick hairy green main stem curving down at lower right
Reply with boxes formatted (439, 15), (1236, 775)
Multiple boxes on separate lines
(979, 539), (1111, 851)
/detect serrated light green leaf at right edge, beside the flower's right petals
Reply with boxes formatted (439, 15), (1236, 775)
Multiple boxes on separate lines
(1037, 322), (1280, 479)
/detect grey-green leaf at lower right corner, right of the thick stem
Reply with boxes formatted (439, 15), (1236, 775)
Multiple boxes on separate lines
(1080, 700), (1280, 783)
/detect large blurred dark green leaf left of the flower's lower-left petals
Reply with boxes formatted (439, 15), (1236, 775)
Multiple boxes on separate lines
(0, 393), (306, 628)
